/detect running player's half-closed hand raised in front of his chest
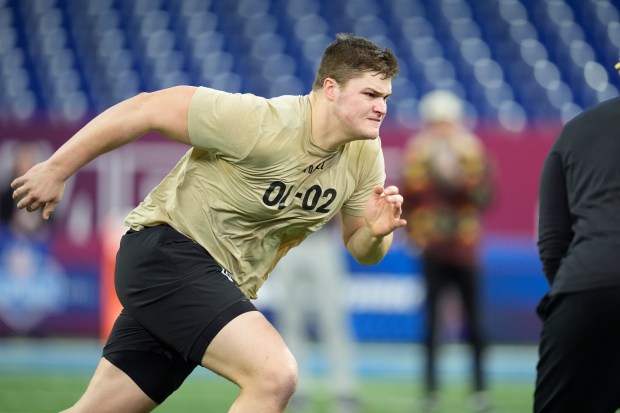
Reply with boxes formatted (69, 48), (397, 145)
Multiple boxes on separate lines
(364, 185), (407, 237)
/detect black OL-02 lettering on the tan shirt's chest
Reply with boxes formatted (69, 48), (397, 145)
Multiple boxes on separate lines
(263, 181), (338, 213)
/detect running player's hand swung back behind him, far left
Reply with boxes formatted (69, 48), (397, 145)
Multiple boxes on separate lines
(11, 162), (65, 220)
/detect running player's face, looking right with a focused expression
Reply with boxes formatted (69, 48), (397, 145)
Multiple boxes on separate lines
(334, 73), (392, 139)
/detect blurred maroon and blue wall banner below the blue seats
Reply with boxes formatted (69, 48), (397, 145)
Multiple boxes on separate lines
(0, 123), (555, 342)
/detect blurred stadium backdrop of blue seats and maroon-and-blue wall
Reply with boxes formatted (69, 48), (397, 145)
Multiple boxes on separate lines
(0, 0), (620, 412)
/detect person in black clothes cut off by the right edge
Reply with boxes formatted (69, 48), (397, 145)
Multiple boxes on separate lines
(534, 94), (620, 413)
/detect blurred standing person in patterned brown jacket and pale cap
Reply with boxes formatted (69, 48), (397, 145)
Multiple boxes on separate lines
(402, 90), (492, 412)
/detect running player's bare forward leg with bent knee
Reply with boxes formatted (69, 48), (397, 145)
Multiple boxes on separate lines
(201, 311), (297, 413)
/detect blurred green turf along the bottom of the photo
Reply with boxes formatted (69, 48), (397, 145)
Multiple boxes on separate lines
(0, 374), (532, 413)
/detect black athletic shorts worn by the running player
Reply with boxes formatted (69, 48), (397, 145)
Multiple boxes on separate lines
(103, 225), (256, 403)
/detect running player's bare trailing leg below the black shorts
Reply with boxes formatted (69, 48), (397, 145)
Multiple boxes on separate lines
(64, 358), (157, 413)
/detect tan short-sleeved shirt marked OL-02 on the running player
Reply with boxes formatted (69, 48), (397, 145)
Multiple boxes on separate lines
(125, 87), (385, 298)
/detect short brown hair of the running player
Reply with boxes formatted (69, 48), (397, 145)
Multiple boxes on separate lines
(312, 33), (398, 90)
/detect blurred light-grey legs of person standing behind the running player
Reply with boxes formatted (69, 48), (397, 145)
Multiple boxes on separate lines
(271, 219), (361, 413)
